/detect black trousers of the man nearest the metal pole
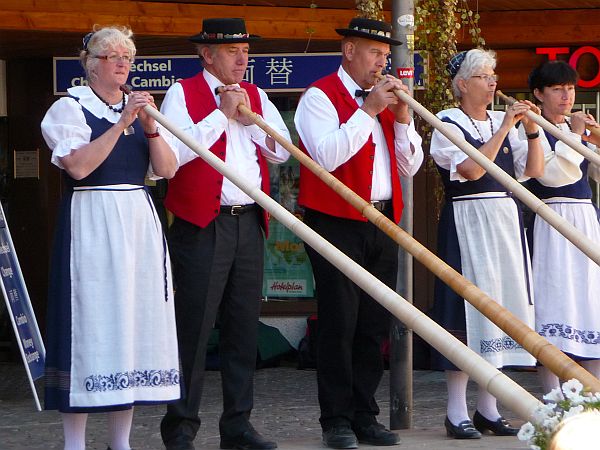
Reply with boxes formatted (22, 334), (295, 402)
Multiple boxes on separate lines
(304, 208), (398, 430)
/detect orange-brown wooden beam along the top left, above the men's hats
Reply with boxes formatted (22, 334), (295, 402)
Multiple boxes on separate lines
(0, 0), (370, 40)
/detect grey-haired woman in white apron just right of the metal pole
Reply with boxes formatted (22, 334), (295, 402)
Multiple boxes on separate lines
(430, 49), (544, 439)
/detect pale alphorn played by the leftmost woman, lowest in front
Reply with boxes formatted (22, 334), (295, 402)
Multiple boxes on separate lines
(122, 87), (541, 420)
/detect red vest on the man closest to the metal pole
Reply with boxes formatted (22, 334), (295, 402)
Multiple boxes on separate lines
(298, 73), (403, 223)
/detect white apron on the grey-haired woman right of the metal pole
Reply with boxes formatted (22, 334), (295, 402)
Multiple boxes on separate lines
(453, 192), (535, 368)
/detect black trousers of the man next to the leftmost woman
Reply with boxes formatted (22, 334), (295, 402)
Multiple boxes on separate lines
(161, 207), (264, 444)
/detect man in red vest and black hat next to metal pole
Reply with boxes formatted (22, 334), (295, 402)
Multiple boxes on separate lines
(294, 18), (423, 448)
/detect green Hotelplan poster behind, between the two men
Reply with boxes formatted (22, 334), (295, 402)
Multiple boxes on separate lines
(263, 158), (314, 298)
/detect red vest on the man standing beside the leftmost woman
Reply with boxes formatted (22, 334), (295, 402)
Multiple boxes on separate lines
(165, 72), (270, 232)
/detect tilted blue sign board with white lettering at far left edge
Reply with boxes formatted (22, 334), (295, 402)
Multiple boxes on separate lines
(0, 205), (46, 411)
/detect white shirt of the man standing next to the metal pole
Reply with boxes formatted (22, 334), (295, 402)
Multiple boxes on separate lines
(294, 66), (424, 201)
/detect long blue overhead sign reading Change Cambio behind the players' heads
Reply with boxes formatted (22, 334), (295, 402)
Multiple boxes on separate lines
(53, 52), (425, 95)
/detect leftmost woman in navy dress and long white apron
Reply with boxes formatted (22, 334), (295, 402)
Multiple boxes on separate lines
(42, 27), (180, 450)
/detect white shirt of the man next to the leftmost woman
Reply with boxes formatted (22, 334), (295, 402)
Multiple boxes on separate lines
(160, 70), (290, 205)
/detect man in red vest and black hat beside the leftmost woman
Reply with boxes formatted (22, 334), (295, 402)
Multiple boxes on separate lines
(161, 15), (289, 450)
